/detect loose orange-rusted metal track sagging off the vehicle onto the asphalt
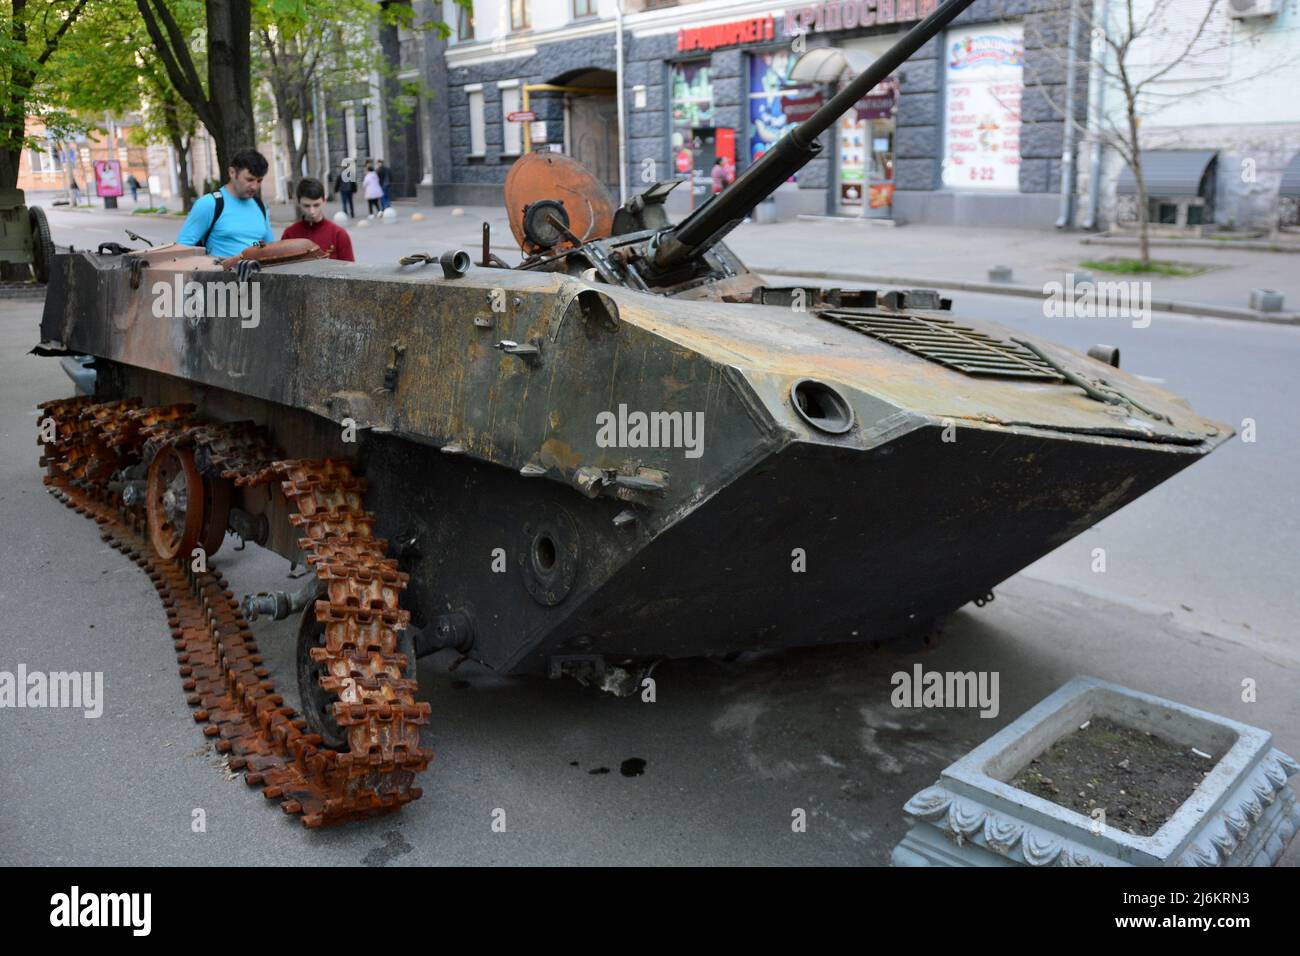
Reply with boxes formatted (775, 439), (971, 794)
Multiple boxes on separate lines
(39, 398), (430, 827)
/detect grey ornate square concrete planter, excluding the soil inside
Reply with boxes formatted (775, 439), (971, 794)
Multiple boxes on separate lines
(893, 678), (1300, 866)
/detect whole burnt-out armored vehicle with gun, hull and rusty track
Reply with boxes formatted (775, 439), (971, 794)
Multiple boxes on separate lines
(32, 0), (1231, 826)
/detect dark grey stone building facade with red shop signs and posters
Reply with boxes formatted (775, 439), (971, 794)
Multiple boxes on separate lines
(426, 0), (1087, 225)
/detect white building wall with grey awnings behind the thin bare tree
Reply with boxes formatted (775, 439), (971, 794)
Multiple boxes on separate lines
(1099, 0), (1300, 232)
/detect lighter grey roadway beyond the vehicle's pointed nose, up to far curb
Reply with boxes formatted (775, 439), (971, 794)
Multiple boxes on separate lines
(889, 293), (1300, 654)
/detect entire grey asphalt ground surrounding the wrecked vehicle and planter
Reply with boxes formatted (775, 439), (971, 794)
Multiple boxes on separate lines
(0, 213), (1300, 865)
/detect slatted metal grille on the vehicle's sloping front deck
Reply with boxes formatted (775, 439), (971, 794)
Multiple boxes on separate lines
(819, 310), (1063, 381)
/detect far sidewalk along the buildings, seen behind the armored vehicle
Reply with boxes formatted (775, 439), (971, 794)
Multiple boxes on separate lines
(29, 194), (1300, 323)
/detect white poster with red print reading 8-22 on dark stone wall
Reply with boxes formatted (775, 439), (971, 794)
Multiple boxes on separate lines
(944, 23), (1024, 191)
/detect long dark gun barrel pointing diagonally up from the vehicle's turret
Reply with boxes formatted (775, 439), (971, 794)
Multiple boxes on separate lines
(650, 0), (975, 269)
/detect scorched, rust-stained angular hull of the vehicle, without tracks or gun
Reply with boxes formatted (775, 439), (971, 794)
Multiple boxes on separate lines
(32, 247), (1231, 672)
